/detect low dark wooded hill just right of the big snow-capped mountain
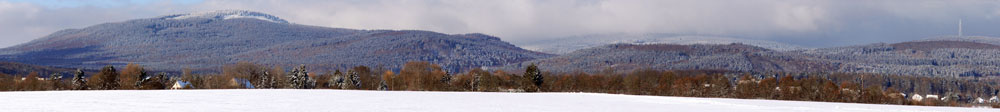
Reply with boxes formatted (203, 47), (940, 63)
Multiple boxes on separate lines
(504, 43), (834, 73)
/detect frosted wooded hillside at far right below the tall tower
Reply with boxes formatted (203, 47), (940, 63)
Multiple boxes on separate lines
(798, 40), (1000, 77)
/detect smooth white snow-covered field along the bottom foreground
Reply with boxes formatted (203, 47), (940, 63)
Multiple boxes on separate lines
(0, 89), (1000, 112)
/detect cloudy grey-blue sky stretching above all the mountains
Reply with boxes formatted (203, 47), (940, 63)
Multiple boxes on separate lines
(0, 0), (1000, 47)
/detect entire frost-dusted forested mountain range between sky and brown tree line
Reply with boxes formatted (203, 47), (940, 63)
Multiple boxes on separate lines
(0, 11), (1000, 76)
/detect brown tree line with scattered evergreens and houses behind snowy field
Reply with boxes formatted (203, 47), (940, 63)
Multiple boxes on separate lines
(0, 62), (1000, 107)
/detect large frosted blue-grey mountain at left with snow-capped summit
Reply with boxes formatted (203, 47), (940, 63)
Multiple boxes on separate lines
(0, 10), (551, 71)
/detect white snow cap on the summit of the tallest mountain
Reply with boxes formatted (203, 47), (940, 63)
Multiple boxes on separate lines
(164, 10), (288, 23)
